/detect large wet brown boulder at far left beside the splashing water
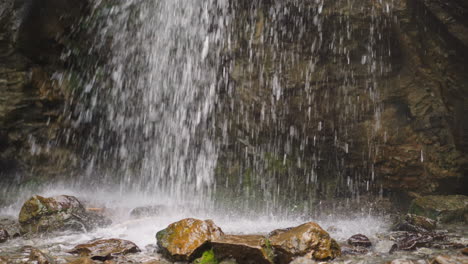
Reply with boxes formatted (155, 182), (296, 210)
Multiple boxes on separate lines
(19, 195), (111, 233)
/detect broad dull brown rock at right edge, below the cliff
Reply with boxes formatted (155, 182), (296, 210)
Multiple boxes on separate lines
(409, 195), (468, 223)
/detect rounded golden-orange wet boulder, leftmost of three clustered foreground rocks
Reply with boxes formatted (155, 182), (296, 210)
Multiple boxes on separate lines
(156, 218), (224, 261)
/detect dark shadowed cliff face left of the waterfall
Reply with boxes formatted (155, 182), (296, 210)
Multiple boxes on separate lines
(0, 0), (86, 187)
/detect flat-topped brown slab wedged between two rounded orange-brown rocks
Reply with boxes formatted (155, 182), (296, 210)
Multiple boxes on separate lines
(211, 235), (274, 264)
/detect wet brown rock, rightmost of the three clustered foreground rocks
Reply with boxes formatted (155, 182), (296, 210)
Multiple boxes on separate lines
(269, 222), (341, 263)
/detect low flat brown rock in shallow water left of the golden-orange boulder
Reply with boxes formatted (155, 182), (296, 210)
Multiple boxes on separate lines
(69, 239), (140, 261)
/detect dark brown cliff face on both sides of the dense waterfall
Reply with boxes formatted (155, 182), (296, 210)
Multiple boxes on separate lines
(0, 0), (468, 199)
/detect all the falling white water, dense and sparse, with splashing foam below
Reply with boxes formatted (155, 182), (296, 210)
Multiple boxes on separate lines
(0, 0), (410, 260)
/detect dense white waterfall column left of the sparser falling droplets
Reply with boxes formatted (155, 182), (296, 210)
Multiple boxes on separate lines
(67, 0), (226, 205)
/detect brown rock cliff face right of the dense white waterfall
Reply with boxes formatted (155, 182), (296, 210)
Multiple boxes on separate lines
(218, 0), (468, 200)
